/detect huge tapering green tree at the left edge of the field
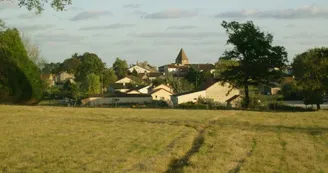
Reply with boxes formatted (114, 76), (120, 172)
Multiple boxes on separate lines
(0, 29), (43, 104)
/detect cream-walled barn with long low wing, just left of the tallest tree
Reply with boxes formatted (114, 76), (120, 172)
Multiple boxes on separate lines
(171, 82), (240, 106)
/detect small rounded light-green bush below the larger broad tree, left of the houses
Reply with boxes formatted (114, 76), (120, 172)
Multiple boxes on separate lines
(83, 73), (101, 94)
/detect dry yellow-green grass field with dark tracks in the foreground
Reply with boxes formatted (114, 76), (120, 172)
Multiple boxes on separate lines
(0, 106), (328, 173)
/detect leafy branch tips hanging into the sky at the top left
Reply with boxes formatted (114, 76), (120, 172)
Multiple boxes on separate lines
(0, 0), (72, 13)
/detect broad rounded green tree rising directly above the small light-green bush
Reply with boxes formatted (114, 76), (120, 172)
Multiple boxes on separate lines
(75, 52), (105, 81)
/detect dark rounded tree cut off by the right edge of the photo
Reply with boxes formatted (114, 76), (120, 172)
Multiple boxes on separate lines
(292, 48), (328, 109)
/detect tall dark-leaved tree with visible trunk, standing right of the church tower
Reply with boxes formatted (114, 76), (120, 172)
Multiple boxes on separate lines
(220, 21), (287, 108)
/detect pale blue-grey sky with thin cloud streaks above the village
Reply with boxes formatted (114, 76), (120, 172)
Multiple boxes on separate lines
(0, 0), (328, 66)
